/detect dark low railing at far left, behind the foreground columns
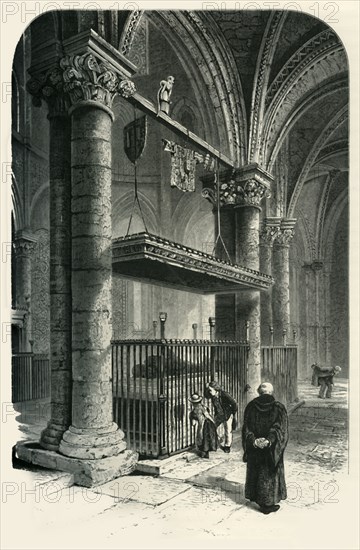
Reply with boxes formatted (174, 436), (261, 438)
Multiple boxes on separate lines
(11, 352), (50, 403)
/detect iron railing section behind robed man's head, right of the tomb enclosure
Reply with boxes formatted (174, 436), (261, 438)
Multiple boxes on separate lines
(261, 345), (297, 404)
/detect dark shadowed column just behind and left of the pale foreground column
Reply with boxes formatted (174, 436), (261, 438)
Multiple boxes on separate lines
(27, 69), (72, 451)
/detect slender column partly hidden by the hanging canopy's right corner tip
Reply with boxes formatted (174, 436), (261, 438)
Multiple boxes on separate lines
(260, 218), (281, 346)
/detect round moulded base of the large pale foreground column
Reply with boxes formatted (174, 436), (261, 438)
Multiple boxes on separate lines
(59, 422), (126, 460)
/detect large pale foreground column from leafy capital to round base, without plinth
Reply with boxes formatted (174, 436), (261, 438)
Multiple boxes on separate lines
(59, 54), (136, 472)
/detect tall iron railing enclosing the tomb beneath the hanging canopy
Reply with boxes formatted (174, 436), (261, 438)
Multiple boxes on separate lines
(112, 340), (248, 458)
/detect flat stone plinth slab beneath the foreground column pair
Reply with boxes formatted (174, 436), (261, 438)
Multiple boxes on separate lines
(15, 441), (138, 487)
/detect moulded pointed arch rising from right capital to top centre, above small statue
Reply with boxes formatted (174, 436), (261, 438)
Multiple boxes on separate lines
(120, 10), (247, 165)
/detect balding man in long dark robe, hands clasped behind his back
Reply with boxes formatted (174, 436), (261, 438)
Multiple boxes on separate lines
(242, 382), (289, 514)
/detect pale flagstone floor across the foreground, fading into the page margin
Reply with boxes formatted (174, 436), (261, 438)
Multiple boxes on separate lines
(2, 388), (359, 550)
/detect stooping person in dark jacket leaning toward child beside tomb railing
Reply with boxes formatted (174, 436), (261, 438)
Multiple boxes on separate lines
(206, 381), (237, 453)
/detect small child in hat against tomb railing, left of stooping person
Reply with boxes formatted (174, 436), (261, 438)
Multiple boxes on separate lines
(189, 393), (218, 458)
